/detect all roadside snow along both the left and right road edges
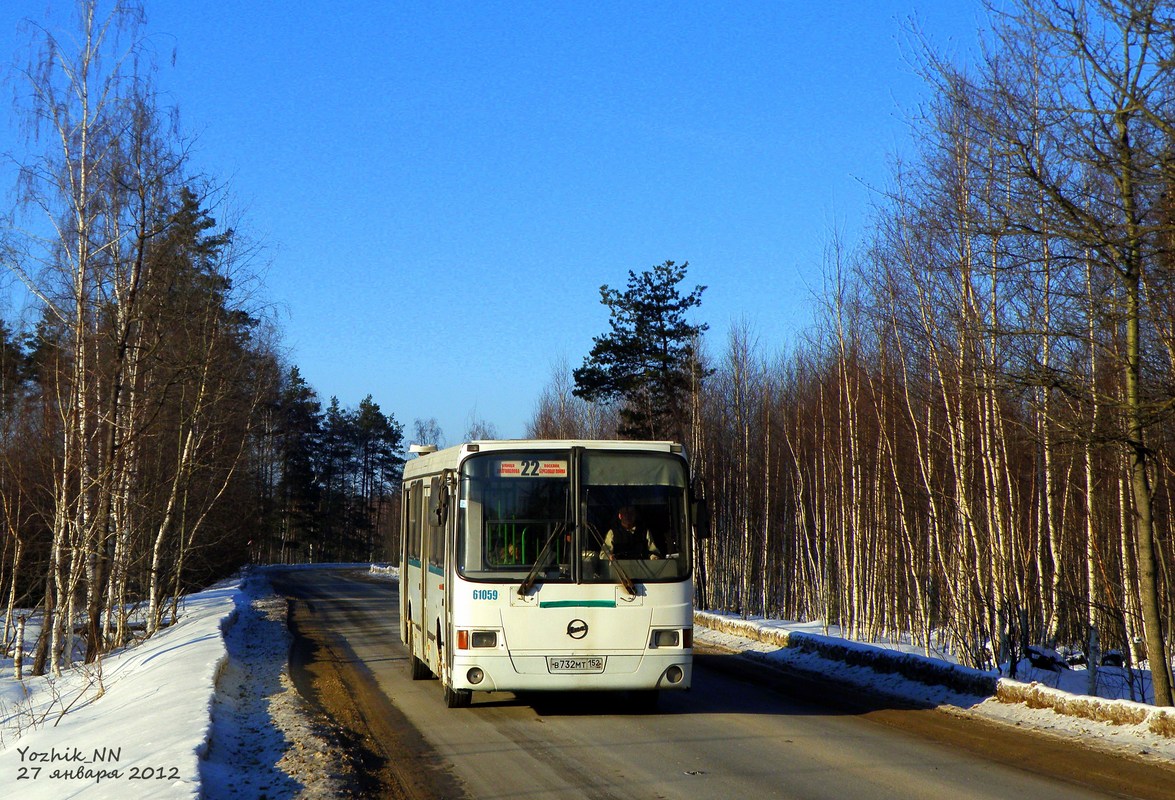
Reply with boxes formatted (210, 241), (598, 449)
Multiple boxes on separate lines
(0, 565), (1175, 800)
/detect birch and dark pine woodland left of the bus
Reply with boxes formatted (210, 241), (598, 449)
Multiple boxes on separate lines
(0, 2), (403, 674)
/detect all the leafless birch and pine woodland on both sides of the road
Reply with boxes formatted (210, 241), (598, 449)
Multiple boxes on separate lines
(0, 0), (1175, 705)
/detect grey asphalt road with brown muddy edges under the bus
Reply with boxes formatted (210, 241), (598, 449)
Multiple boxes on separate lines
(271, 570), (1175, 800)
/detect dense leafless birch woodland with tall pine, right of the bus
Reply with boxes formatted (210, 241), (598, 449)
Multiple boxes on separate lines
(530, 0), (1175, 705)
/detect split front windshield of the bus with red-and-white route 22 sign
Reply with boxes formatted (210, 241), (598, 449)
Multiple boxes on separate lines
(457, 450), (690, 584)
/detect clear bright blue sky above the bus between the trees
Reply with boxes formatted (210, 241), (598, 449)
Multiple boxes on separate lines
(0, 0), (982, 443)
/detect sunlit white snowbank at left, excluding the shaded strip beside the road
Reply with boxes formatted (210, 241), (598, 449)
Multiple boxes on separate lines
(0, 583), (241, 800)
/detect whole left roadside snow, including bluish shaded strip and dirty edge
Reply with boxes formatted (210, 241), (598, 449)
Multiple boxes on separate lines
(0, 570), (354, 800)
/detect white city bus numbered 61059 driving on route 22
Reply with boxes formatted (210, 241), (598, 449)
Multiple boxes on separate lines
(400, 439), (709, 708)
